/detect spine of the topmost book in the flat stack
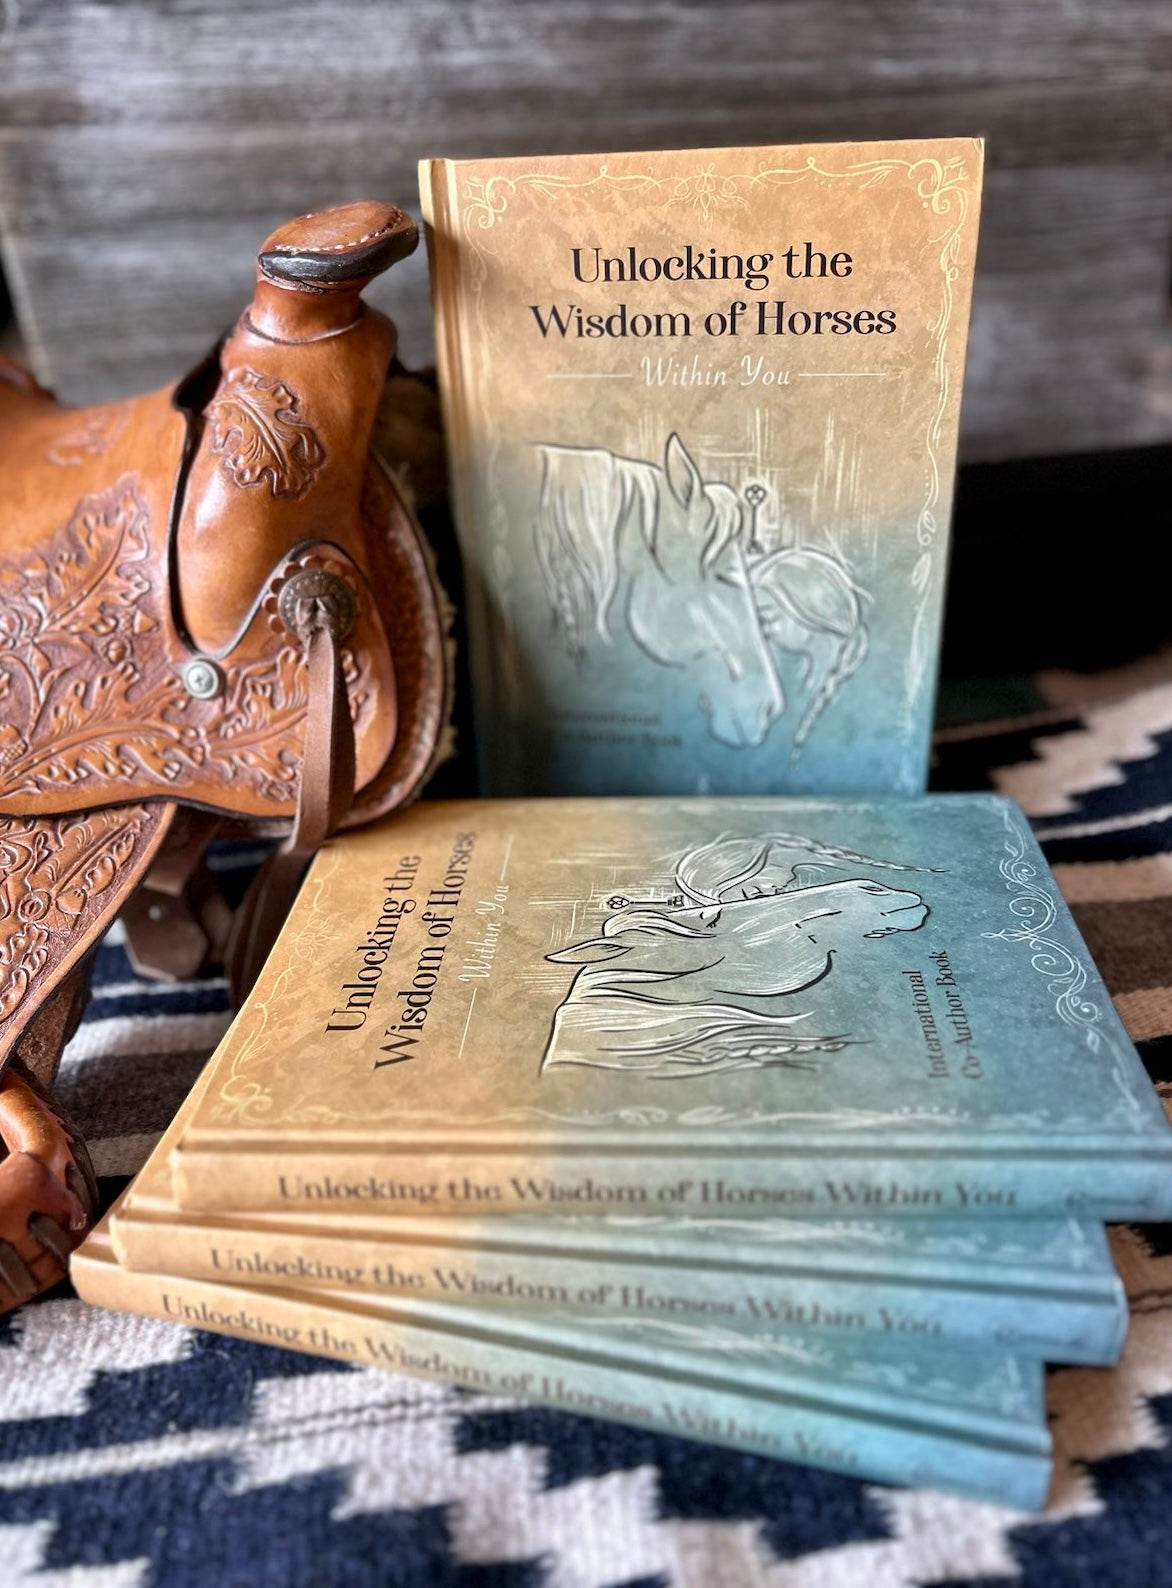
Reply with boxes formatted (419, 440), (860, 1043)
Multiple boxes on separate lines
(172, 1140), (1172, 1223)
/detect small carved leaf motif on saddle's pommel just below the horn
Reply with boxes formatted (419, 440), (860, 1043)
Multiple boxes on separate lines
(208, 368), (326, 502)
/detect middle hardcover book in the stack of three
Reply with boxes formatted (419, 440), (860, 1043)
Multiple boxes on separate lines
(110, 1070), (1128, 1366)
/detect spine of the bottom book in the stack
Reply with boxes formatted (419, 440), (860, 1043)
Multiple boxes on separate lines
(71, 1250), (1050, 1510)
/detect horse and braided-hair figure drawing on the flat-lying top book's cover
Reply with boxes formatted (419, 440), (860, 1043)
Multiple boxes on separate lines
(542, 832), (929, 1080)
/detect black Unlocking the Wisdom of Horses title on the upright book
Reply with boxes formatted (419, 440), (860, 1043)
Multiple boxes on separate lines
(529, 243), (897, 341)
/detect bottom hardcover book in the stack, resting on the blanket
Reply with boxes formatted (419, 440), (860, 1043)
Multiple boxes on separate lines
(71, 1224), (1050, 1510)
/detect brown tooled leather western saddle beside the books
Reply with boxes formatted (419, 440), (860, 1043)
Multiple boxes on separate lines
(0, 203), (449, 1312)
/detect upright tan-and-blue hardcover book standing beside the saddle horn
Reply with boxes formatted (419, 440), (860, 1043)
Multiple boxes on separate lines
(419, 138), (983, 794)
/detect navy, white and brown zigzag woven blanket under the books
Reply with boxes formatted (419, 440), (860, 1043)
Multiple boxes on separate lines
(0, 656), (1172, 1588)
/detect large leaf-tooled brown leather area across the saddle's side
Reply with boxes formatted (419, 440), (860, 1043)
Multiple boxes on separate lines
(0, 475), (353, 815)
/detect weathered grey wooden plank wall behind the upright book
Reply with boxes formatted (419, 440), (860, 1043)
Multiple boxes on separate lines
(0, 0), (1172, 457)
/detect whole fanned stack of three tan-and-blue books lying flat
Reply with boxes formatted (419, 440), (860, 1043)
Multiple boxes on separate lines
(73, 796), (1172, 1509)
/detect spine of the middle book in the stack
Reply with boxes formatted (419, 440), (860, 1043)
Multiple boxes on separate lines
(111, 1215), (1128, 1367)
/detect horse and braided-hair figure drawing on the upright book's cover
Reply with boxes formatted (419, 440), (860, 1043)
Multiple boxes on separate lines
(535, 432), (867, 765)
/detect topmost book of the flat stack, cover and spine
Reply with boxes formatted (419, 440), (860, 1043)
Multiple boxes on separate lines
(173, 796), (1172, 1220)
